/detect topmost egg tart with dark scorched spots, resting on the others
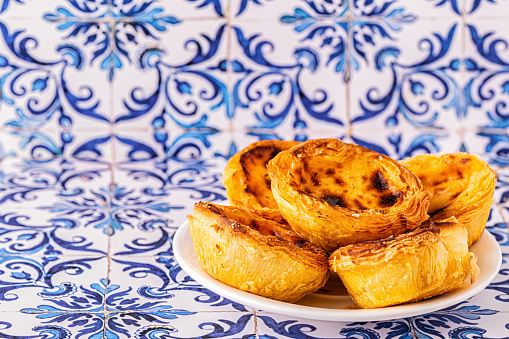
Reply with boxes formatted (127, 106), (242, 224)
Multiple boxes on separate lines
(267, 138), (429, 252)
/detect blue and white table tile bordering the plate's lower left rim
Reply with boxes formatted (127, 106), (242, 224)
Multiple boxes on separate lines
(106, 258), (250, 312)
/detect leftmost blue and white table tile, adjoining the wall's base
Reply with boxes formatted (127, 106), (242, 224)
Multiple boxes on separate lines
(0, 163), (111, 255)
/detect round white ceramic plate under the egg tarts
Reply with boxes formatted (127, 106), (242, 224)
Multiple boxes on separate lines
(173, 221), (502, 322)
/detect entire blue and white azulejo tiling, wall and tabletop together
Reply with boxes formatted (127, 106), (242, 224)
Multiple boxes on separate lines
(0, 0), (509, 339)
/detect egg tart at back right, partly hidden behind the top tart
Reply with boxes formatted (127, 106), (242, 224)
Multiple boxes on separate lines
(401, 153), (497, 246)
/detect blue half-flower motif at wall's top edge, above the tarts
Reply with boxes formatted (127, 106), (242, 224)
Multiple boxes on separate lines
(281, 1), (416, 81)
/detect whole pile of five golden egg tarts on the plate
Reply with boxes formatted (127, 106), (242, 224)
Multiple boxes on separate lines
(188, 138), (497, 308)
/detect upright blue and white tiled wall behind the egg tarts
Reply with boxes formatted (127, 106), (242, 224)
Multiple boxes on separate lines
(0, 0), (509, 165)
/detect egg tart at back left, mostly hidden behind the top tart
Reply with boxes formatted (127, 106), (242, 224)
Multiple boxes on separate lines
(223, 140), (298, 222)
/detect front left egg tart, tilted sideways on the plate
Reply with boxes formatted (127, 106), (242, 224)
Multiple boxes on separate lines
(188, 202), (329, 302)
